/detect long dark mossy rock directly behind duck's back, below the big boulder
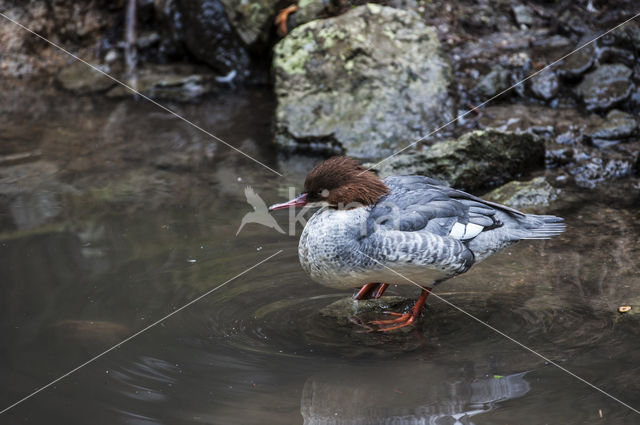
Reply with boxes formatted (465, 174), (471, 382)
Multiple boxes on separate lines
(379, 129), (544, 191)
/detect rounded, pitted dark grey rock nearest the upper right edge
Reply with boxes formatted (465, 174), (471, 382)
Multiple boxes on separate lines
(576, 64), (633, 110)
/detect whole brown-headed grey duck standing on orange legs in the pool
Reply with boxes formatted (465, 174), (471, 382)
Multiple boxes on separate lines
(269, 156), (565, 331)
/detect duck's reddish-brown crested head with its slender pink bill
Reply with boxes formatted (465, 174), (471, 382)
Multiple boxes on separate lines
(269, 156), (389, 211)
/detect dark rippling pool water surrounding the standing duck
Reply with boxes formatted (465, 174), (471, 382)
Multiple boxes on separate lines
(0, 91), (640, 424)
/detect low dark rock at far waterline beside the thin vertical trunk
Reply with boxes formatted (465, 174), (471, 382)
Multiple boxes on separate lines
(107, 64), (215, 101)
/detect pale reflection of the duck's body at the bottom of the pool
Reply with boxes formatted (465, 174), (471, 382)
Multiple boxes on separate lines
(300, 364), (530, 425)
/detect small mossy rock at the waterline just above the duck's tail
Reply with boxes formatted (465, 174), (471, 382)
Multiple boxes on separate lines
(483, 177), (562, 210)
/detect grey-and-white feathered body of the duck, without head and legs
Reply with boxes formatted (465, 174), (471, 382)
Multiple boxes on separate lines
(298, 176), (564, 288)
